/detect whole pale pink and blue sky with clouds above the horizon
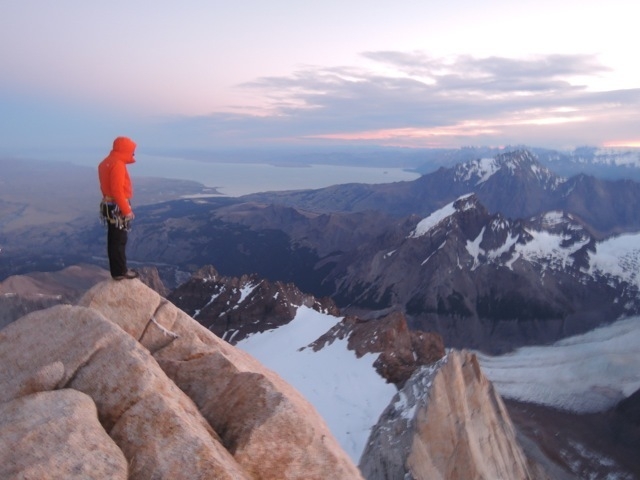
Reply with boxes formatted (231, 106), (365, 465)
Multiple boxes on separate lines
(0, 0), (640, 159)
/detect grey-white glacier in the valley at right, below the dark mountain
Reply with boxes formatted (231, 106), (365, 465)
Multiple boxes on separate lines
(476, 317), (640, 413)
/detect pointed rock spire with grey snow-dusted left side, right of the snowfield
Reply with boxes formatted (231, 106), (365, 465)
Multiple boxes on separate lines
(360, 351), (544, 480)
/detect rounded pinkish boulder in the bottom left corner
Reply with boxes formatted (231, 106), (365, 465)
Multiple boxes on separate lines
(0, 389), (127, 480)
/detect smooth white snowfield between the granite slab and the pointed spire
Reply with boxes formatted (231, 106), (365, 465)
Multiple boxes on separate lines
(236, 307), (397, 464)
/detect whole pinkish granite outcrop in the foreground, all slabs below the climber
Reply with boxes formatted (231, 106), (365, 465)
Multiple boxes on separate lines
(0, 280), (361, 479)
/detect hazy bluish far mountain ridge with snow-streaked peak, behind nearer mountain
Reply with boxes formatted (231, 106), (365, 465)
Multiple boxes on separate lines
(243, 150), (640, 236)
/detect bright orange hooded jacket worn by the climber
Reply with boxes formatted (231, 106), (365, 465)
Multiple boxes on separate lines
(98, 137), (136, 215)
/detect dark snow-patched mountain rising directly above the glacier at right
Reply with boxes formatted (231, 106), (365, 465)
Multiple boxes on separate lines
(335, 194), (640, 352)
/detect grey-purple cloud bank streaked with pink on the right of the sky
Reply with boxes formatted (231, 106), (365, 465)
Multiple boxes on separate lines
(149, 51), (640, 146)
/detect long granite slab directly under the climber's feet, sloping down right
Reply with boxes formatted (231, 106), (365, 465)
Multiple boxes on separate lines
(80, 281), (359, 479)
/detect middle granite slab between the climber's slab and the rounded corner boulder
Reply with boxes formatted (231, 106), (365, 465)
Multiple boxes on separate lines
(0, 304), (246, 479)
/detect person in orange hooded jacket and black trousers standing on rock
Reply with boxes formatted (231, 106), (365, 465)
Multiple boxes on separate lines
(98, 137), (138, 280)
